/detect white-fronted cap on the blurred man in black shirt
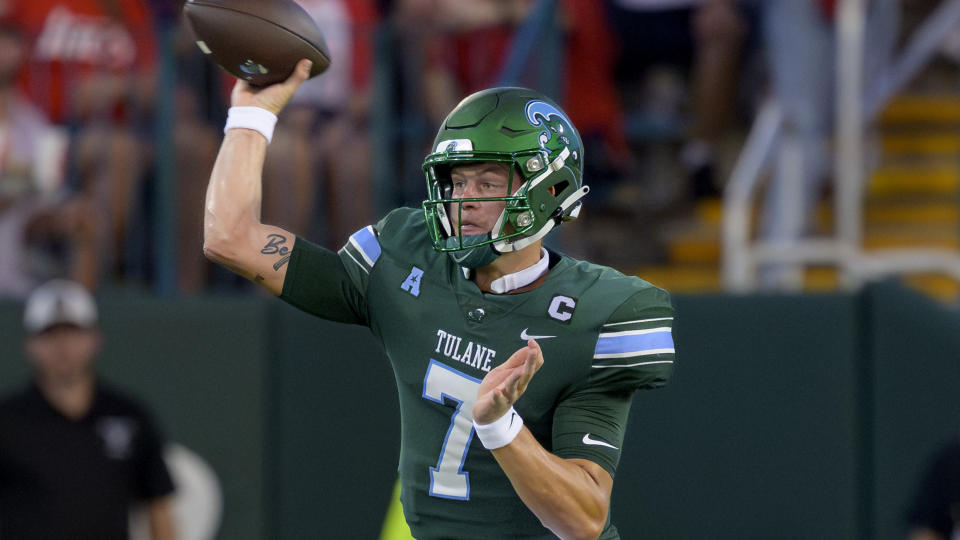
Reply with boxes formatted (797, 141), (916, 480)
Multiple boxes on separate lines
(23, 279), (97, 333)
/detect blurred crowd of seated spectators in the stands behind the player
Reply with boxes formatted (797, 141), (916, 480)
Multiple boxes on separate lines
(0, 0), (924, 298)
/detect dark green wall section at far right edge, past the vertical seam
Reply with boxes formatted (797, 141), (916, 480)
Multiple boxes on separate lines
(867, 283), (960, 540)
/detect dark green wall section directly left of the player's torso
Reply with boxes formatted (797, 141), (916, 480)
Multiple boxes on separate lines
(269, 303), (400, 540)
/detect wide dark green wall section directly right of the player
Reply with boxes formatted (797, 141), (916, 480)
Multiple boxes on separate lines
(612, 295), (859, 540)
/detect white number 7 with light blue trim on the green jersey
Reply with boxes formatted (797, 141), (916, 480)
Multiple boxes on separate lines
(423, 358), (480, 501)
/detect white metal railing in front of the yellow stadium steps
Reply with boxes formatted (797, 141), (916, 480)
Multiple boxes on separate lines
(722, 0), (960, 292)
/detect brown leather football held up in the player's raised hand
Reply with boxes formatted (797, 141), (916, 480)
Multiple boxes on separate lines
(183, 0), (330, 86)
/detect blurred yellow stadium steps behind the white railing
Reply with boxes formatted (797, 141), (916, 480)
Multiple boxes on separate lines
(635, 92), (960, 301)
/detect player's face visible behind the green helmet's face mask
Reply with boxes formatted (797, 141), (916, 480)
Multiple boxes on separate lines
(448, 162), (510, 236)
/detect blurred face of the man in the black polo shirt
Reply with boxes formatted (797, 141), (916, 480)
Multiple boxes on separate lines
(26, 325), (100, 381)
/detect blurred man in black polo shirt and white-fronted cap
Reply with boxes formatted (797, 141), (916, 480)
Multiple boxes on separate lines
(0, 280), (174, 540)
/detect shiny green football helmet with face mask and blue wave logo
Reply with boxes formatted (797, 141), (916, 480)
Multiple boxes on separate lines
(423, 88), (589, 268)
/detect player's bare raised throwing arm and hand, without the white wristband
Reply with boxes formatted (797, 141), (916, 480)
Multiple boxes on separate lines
(203, 60), (310, 295)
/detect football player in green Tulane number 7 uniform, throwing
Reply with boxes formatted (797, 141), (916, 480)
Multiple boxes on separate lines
(204, 61), (674, 539)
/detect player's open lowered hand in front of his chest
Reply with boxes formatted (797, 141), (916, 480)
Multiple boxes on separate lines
(473, 339), (543, 425)
